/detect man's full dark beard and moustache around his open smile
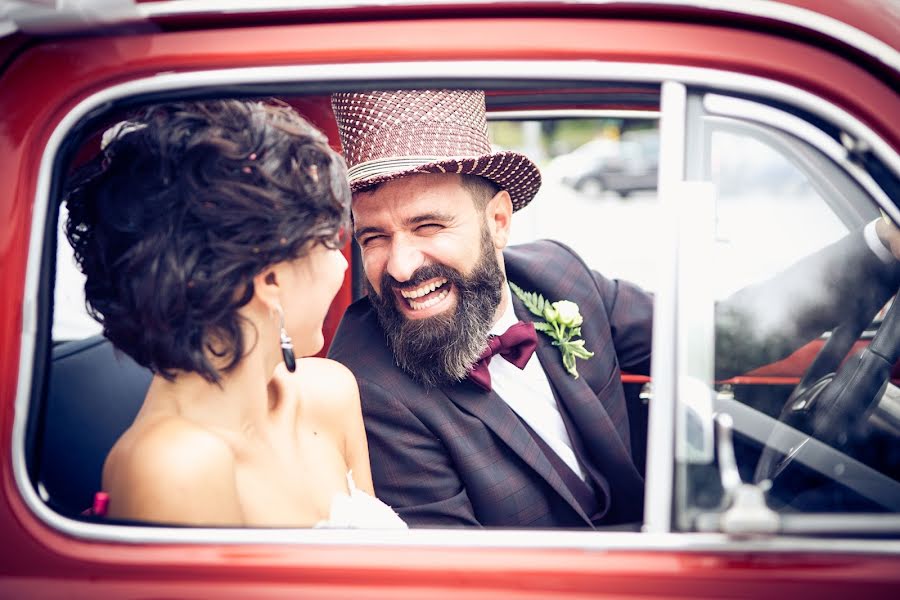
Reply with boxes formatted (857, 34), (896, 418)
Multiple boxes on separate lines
(366, 227), (505, 387)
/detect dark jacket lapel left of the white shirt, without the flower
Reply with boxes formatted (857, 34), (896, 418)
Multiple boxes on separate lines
(443, 370), (591, 524)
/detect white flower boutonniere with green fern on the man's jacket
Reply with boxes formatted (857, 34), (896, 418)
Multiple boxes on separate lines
(509, 282), (594, 379)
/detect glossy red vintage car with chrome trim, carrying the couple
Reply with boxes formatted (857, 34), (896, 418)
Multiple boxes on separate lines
(0, 0), (900, 599)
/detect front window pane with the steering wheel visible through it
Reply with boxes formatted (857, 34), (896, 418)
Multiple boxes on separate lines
(677, 96), (900, 530)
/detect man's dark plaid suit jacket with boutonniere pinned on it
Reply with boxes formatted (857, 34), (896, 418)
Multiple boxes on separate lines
(329, 241), (652, 527)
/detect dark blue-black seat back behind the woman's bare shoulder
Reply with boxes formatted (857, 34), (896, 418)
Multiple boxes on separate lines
(38, 336), (152, 515)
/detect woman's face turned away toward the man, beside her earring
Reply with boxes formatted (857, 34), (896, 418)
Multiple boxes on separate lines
(282, 244), (347, 357)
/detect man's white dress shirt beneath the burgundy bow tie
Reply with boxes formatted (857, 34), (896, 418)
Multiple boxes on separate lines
(488, 286), (585, 479)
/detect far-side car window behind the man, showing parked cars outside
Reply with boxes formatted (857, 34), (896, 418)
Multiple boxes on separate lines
(489, 116), (660, 291)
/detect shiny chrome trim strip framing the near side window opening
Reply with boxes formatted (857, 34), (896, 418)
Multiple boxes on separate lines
(11, 61), (900, 552)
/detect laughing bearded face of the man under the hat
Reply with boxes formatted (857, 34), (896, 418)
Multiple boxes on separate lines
(353, 174), (512, 385)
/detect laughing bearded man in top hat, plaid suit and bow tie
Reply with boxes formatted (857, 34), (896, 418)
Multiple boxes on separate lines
(329, 90), (900, 527)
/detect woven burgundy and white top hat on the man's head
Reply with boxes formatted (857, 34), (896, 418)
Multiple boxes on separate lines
(331, 90), (541, 211)
